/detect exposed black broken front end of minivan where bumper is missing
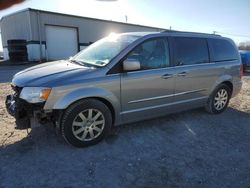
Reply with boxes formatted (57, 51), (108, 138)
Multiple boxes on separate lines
(5, 87), (55, 130)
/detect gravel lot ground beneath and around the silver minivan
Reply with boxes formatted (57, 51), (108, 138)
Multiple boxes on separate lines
(0, 67), (250, 188)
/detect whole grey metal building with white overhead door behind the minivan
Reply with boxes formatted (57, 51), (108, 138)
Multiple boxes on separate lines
(0, 8), (165, 61)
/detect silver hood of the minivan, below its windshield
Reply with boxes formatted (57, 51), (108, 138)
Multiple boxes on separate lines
(12, 60), (96, 87)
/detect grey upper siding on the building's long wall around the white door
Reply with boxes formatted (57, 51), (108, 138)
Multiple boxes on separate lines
(30, 11), (163, 43)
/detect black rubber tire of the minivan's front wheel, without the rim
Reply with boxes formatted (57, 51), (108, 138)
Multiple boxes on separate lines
(61, 99), (112, 147)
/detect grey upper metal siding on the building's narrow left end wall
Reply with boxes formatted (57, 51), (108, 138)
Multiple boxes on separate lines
(0, 11), (32, 47)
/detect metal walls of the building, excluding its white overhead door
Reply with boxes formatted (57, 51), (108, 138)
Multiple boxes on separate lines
(0, 9), (166, 61)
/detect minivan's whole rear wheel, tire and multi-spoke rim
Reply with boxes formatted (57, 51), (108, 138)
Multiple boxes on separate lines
(205, 84), (231, 114)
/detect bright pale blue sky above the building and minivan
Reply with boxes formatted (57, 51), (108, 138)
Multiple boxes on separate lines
(0, 0), (250, 51)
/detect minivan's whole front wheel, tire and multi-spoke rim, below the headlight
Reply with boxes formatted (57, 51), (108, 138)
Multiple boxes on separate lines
(61, 99), (112, 147)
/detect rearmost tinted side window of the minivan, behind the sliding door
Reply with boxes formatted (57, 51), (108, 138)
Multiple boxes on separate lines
(210, 39), (238, 62)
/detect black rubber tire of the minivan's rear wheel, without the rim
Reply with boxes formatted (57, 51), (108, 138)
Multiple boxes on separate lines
(205, 84), (232, 114)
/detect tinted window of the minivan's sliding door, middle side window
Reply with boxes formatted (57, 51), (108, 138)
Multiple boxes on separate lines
(174, 37), (209, 65)
